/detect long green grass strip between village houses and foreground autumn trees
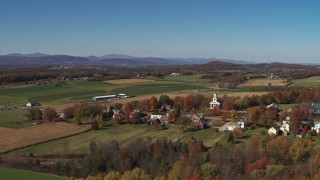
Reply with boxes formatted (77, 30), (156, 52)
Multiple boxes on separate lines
(11, 124), (227, 155)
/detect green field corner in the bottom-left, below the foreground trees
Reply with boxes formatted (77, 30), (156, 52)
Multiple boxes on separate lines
(0, 167), (65, 180)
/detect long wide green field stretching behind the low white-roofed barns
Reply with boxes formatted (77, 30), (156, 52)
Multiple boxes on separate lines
(0, 81), (211, 106)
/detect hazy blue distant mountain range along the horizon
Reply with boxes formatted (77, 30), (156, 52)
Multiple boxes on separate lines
(0, 53), (316, 67)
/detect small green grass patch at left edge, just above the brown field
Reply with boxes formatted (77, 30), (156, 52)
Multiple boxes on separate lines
(0, 109), (31, 128)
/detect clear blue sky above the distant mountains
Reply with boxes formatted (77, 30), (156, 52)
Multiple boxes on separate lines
(0, 0), (320, 63)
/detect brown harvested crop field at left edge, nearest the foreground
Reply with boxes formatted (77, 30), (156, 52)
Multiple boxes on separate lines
(0, 122), (91, 154)
